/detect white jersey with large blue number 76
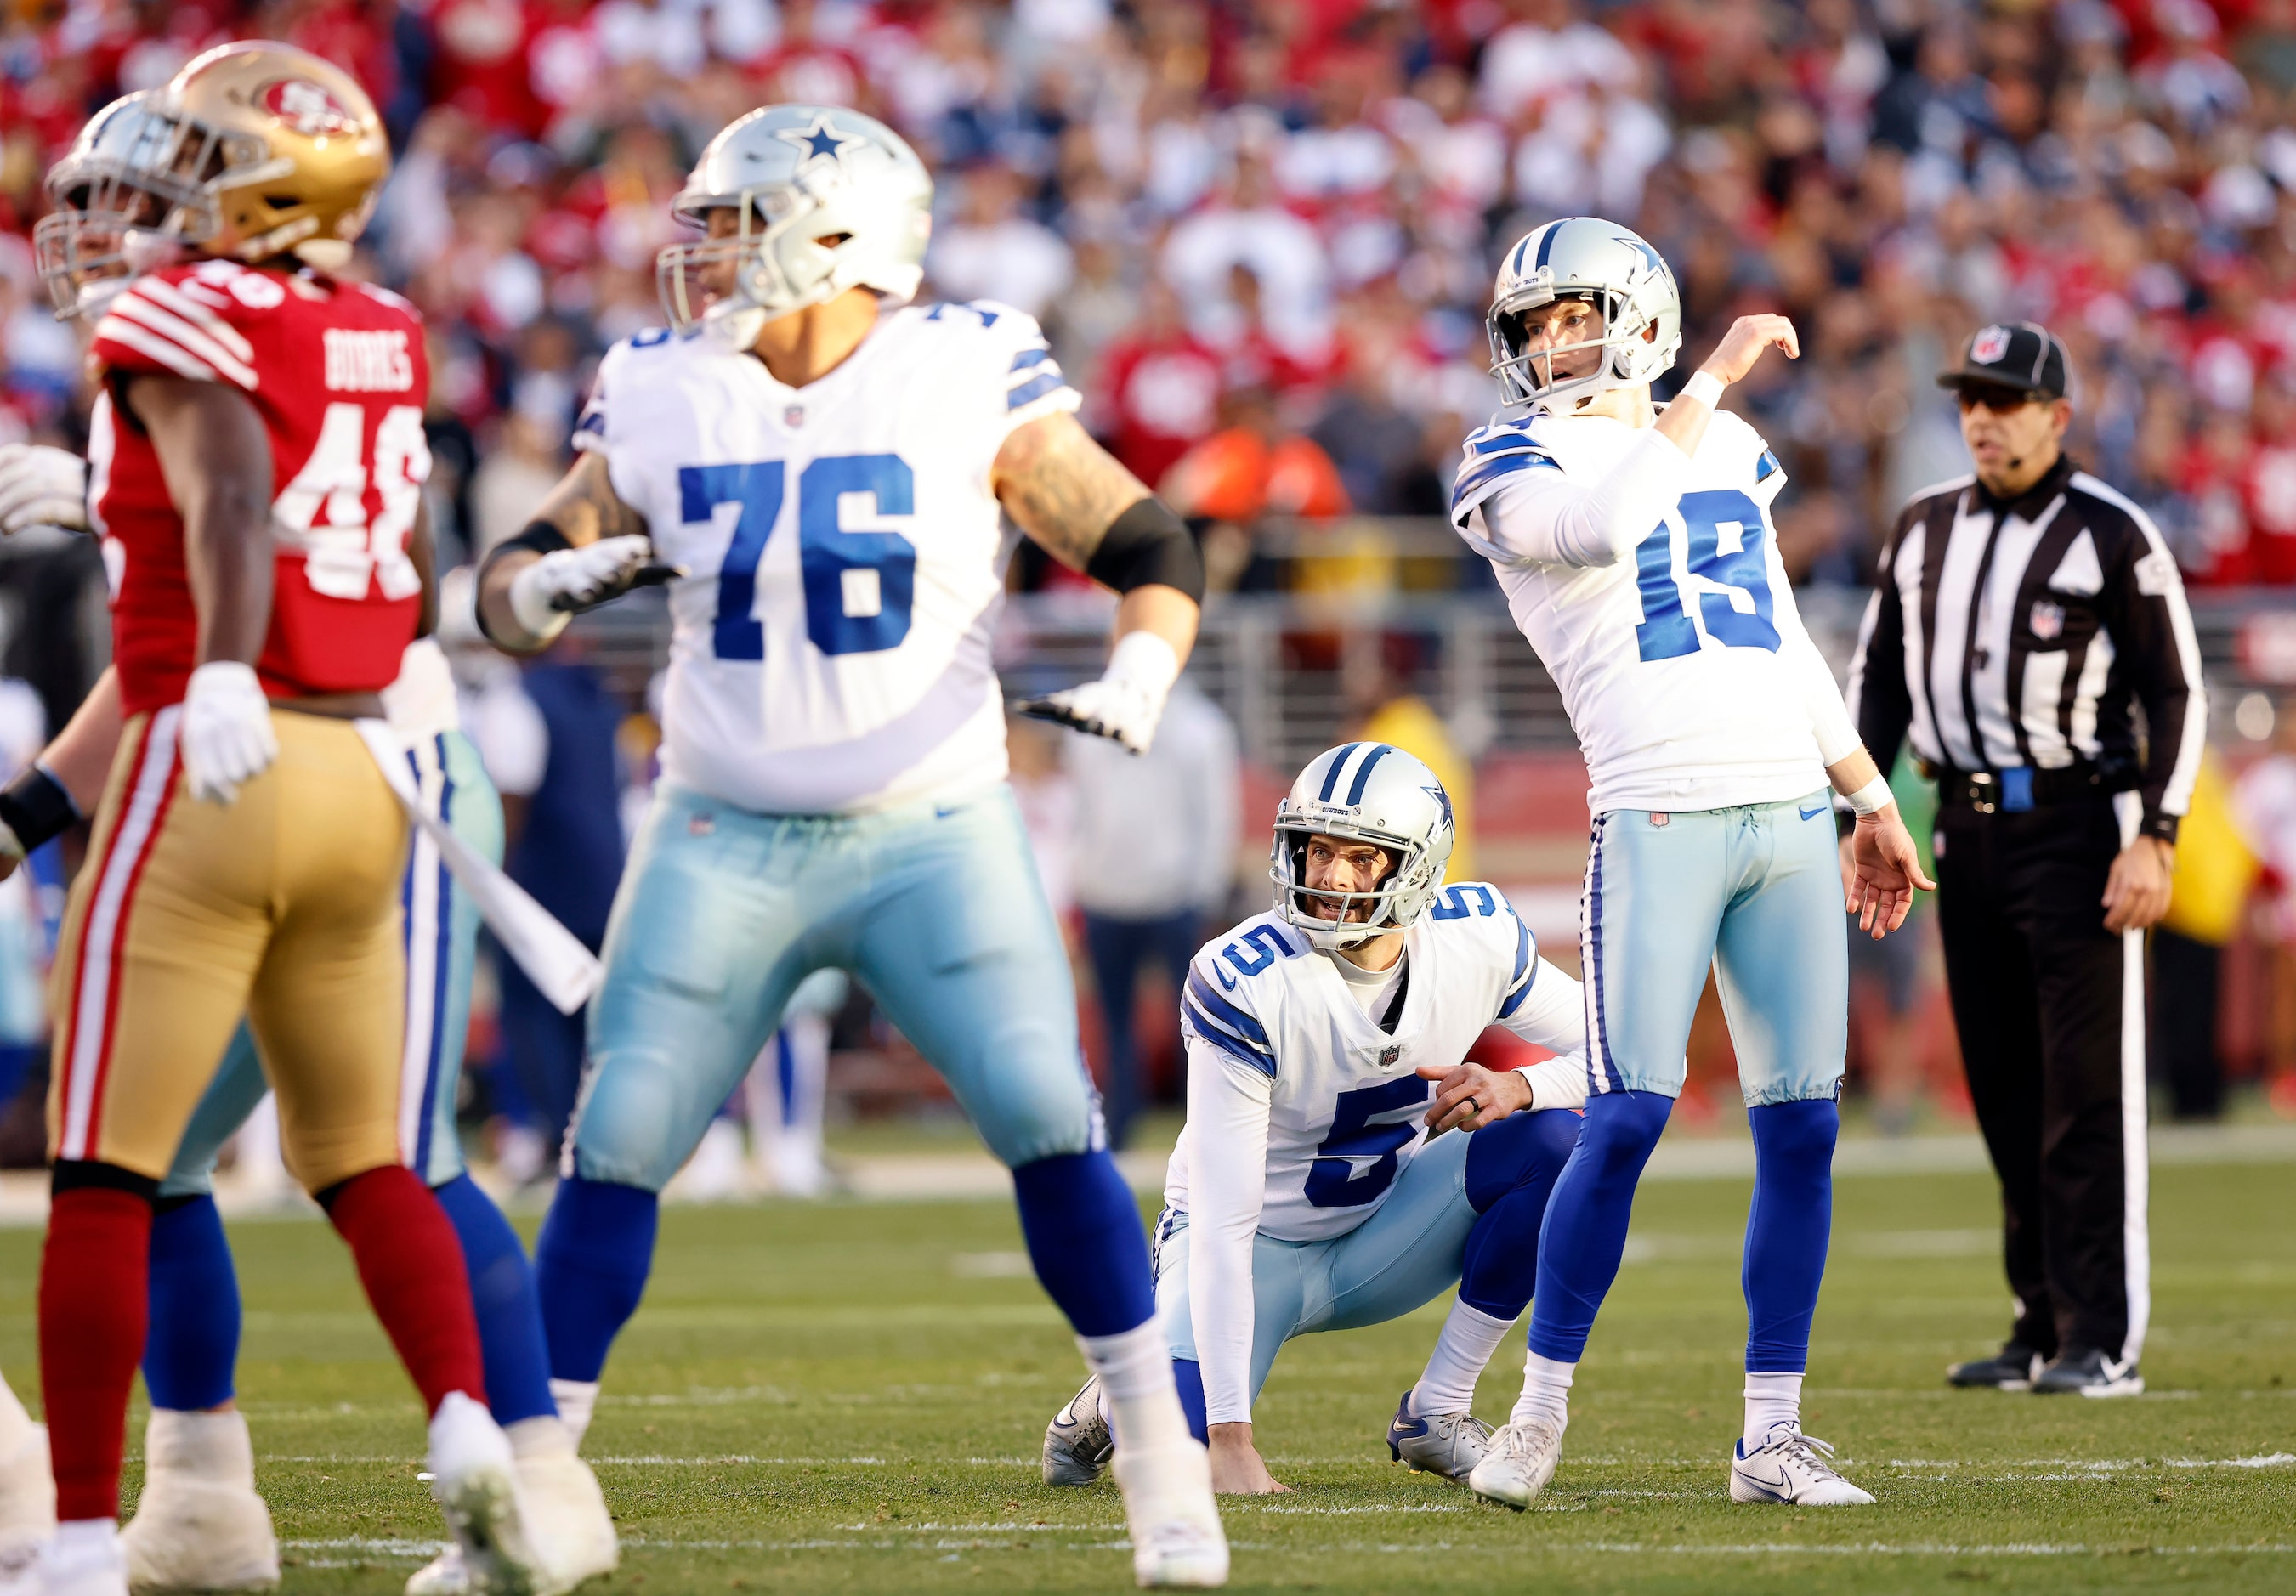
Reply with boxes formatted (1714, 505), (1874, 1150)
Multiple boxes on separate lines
(574, 303), (1079, 815)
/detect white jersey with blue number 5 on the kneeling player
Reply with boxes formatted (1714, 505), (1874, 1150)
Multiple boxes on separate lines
(1164, 882), (1586, 1242)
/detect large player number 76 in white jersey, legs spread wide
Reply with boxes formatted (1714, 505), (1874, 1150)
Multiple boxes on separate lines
(463, 105), (1228, 1584)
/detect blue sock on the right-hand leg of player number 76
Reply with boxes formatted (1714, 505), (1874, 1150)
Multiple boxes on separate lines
(1012, 1148), (1155, 1337)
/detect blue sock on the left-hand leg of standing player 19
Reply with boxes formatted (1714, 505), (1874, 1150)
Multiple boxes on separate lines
(1524, 1091), (1674, 1364)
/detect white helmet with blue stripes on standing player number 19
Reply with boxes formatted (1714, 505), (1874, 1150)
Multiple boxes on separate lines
(1483, 216), (1683, 416)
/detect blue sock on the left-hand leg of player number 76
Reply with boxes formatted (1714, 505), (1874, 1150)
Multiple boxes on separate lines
(535, 1176), (661, 1380)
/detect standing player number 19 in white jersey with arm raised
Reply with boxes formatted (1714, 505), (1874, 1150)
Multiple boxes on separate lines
(1451, 216), (1929, 1507)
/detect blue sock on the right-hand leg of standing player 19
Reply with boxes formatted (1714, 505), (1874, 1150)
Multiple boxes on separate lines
(1745, 1098), (1841, 1373)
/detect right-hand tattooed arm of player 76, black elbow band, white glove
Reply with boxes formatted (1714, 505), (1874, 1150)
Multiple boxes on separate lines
(989, 411), (1203, 753)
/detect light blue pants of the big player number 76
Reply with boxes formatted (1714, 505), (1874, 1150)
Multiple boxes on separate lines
(567, 783), (1104, 1191)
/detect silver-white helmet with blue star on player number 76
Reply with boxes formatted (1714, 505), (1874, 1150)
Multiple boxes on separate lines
(655, 105), (933, 349)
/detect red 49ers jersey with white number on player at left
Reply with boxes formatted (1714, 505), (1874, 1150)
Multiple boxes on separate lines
(88, 259), (429, 714)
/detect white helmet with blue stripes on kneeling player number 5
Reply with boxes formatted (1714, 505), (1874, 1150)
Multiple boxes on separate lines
(1267, 742), (1458, 953)
